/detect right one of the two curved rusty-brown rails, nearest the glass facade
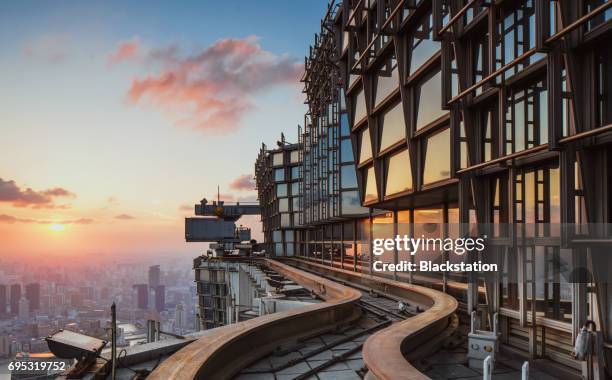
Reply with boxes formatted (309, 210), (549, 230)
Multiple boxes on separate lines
(290, 260), (458, 380)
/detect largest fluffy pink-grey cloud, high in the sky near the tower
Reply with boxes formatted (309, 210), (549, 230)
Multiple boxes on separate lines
(122, 37), (303, 133)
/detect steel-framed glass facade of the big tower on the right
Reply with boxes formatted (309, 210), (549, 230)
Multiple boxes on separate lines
(253, 0), (612, 367)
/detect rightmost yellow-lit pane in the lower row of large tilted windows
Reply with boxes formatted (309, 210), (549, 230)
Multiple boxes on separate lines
(423, 129), (451, 184)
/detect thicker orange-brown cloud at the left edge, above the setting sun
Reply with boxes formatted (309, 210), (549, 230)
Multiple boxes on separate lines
(0, 178), (76, 208)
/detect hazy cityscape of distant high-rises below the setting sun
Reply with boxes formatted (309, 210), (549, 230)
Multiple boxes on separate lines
(0, 257), (197, 362)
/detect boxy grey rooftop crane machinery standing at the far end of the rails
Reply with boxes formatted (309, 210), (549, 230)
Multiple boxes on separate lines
(185, 198), (260, 256)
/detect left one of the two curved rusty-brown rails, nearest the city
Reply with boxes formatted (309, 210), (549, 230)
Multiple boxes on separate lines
(147, 260), (361, 380)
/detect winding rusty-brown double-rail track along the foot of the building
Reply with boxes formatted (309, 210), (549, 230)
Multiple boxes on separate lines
(149, 259), (458, 380)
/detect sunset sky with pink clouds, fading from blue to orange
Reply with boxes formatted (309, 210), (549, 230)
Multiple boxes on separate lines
(0, 0), (327, 258)
